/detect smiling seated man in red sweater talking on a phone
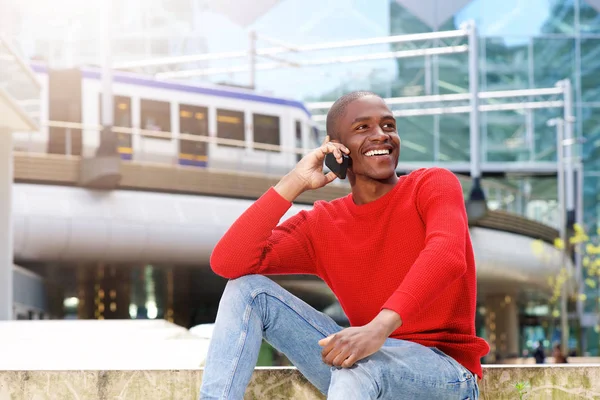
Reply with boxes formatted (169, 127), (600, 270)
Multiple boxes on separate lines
(200, 92), (489, 400)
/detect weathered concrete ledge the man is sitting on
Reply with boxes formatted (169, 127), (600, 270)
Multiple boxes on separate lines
(0, 364), (600, 400)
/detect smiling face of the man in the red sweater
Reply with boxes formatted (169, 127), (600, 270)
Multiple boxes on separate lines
(337, 96), (400, 180)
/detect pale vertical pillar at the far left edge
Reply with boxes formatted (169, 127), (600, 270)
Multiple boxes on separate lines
(0, 130), (13, 321)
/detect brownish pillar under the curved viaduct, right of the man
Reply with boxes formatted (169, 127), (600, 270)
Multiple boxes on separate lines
(485, 295), (520, 362)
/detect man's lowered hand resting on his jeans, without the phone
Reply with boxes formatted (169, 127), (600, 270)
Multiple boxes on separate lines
(319, 325), (387, 368)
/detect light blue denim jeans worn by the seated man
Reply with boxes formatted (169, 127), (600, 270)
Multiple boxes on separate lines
(200, 275), (479, 400)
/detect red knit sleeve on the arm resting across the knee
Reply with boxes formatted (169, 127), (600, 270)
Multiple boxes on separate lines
(382, 168), (468, 323)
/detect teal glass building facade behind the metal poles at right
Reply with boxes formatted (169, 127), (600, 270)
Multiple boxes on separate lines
(390, 0), (600, 355)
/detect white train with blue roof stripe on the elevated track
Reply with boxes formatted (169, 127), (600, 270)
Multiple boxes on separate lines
(15, 64), (318, 173)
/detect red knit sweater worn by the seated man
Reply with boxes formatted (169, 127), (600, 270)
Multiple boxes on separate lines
(211, 168), (489, 377)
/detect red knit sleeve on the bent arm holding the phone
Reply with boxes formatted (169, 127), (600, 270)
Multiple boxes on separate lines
(210, 188), (315, 279)
